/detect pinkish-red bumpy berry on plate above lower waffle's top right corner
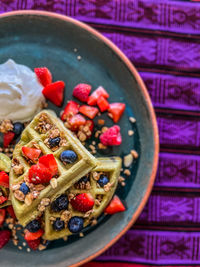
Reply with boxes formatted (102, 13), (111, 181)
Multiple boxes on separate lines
(100, 125), (122, 146)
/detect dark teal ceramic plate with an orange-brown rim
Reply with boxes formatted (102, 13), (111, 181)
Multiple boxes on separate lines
(0, 11), (158, 267)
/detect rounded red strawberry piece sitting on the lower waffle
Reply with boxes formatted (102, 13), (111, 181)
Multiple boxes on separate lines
(71, 193), (94, 212)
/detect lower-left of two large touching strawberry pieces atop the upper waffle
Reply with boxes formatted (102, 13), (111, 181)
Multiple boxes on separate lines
(28, 163), (52, 184)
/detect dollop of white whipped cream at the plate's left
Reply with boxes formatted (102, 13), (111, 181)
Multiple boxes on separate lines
(0, 59), (44, 122)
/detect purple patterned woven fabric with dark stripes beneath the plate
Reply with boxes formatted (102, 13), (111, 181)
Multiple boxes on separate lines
(0, 0), (200, 266)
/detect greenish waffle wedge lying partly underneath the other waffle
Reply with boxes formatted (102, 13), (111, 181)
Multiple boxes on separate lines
(44, 157), (121, 240)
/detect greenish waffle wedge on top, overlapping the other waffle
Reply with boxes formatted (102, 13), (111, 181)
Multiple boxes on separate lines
(10, 110), (98, 226)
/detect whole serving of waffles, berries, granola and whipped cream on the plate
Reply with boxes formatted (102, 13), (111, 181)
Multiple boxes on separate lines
(0, 60), (138, 251)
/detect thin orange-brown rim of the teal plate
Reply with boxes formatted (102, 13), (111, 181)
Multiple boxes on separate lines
(0, 9), (159, 267)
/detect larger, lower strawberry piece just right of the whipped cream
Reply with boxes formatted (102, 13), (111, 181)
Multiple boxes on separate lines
(42, 81), (65, 107)
